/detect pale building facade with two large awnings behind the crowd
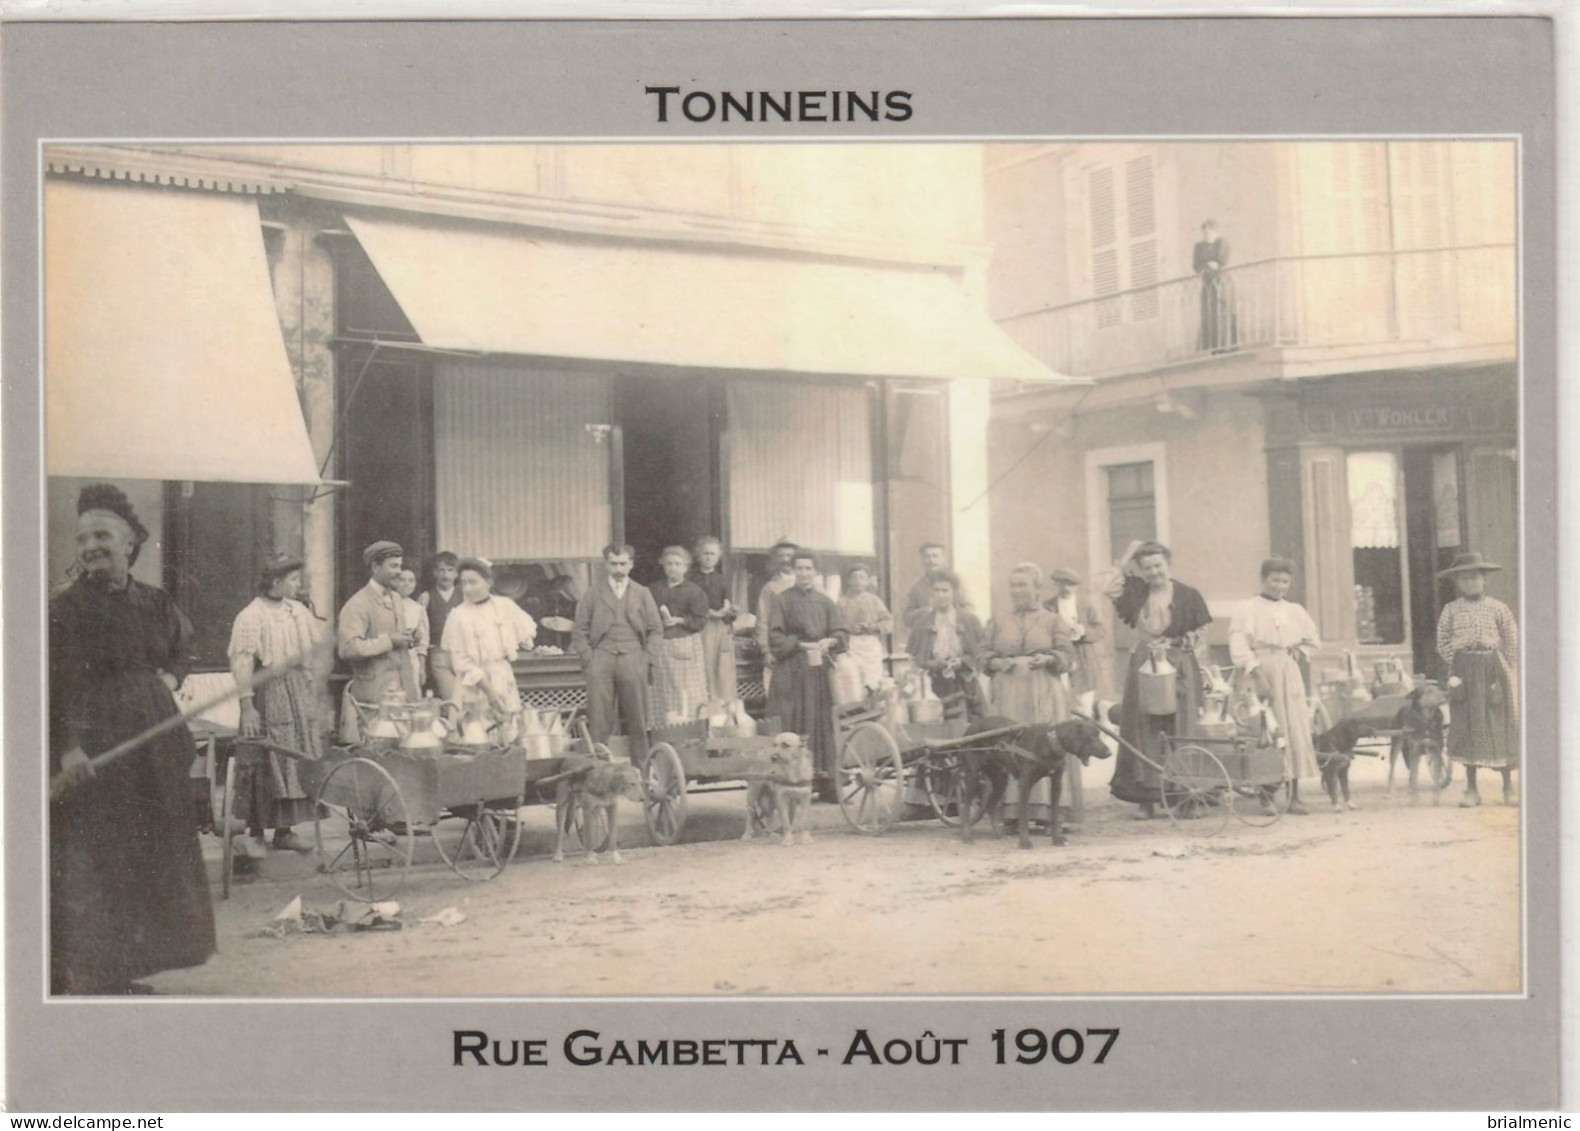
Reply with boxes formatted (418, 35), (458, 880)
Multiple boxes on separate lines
(46, 145), (1057, 703)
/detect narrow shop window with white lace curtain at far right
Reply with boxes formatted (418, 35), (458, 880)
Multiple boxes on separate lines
(1345, 452), (1406, 644)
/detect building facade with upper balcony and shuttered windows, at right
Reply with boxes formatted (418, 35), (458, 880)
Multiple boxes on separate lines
(986, 141), (1520, 688)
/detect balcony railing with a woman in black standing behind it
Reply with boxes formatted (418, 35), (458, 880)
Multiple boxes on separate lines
(1000, 243), (1515, 378)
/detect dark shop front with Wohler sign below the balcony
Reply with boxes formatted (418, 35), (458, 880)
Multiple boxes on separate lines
(1266, 365), (1520, 676)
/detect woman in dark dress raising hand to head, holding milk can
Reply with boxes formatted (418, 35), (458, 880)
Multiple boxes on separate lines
(1108, 542), (1212, 818)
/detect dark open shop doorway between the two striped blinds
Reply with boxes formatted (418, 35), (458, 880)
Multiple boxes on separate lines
(615, 376), (724, 584)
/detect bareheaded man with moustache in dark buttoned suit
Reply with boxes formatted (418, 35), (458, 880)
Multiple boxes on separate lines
(570, 545), (664, 765)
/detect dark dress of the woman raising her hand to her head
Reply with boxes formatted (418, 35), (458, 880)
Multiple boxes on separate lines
(1108, 577), (1212, 806)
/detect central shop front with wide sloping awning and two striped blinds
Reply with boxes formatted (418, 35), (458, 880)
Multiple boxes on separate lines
(333, 199), (1054, 706)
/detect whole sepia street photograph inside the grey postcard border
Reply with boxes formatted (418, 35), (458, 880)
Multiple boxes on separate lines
(40, 139), (1516, 998)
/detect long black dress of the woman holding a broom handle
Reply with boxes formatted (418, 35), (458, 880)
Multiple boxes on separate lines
(49, 580), (215, 994)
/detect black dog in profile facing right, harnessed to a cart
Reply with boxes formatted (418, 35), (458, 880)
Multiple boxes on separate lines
(959, 716), (1109, 848)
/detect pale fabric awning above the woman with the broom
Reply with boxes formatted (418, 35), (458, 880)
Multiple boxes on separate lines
(44, 180), (319, 483)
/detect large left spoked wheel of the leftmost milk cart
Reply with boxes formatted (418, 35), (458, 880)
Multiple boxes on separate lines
(313, 758), (412, 904)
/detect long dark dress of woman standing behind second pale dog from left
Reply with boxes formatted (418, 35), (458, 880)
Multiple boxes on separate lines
(768, 586), (850, 782)
